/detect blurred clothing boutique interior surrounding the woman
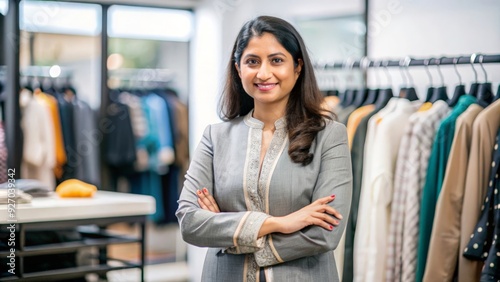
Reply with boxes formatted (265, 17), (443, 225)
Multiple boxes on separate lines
(0, 0), (500, 282)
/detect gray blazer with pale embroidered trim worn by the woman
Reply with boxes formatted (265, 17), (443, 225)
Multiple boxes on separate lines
(176, 112), (352, 282)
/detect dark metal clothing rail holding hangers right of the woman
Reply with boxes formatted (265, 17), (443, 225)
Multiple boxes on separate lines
(314, 53), (500, 70)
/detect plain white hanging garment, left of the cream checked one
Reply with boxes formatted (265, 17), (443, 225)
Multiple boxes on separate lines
(354, 98), (421, 281)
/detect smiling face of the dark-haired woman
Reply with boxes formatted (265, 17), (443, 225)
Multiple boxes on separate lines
(236, 32), (302, 109)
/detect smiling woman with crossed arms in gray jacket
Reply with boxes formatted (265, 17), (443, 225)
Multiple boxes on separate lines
(176, 16), (352, 282)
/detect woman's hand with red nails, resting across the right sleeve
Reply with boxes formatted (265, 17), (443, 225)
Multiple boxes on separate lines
(258, 195), (342, 237)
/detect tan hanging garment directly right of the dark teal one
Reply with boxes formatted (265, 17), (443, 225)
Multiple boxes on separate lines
(424, 104), (483, 282)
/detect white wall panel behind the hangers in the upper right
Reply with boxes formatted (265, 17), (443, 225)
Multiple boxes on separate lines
(368, 0), (500, 98)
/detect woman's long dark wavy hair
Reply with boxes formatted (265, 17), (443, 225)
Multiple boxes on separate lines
(220, 16), (331, 165)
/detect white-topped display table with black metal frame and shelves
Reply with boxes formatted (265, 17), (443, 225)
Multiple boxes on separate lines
(0, 191), (155, 281)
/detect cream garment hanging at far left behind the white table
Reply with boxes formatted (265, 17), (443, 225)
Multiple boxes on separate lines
(20, 89), (56, 190)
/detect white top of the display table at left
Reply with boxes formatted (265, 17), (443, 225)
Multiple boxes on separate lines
(0, 191), (155, 224)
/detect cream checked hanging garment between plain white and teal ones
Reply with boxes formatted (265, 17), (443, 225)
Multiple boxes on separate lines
(386, 101), (450, 281)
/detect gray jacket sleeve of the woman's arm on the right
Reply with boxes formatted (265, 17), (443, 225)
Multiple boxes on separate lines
(254, 122), (352, 267)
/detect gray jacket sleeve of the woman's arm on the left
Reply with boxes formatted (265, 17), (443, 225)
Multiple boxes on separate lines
(176, 126), (269, 253)
